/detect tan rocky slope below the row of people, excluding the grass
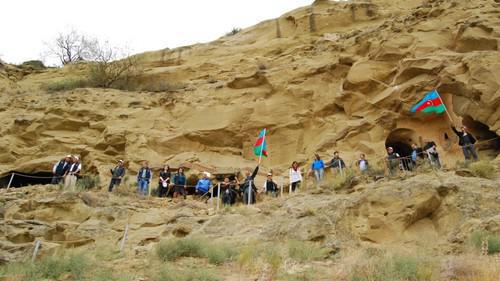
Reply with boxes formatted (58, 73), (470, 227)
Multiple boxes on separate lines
(0, 167), (500, 280)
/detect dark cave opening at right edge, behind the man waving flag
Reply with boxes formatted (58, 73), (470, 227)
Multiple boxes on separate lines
(462, 115), (500, 153)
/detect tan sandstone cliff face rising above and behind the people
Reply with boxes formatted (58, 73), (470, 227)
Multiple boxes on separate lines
(0, 0), (500, 178)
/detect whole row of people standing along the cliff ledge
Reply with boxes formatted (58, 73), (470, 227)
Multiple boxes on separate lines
(52, 126), (478, 205)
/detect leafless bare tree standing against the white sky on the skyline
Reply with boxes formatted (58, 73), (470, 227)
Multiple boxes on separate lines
(45, 29), (98, 65)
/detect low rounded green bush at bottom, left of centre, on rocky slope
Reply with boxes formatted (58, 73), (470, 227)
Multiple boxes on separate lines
(156, 238), (237, 265)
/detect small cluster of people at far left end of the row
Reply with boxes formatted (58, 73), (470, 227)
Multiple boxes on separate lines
(51, 155), (82, 189)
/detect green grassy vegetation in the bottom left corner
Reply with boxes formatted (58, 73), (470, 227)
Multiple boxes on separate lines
(0, 250), (127, 281)
